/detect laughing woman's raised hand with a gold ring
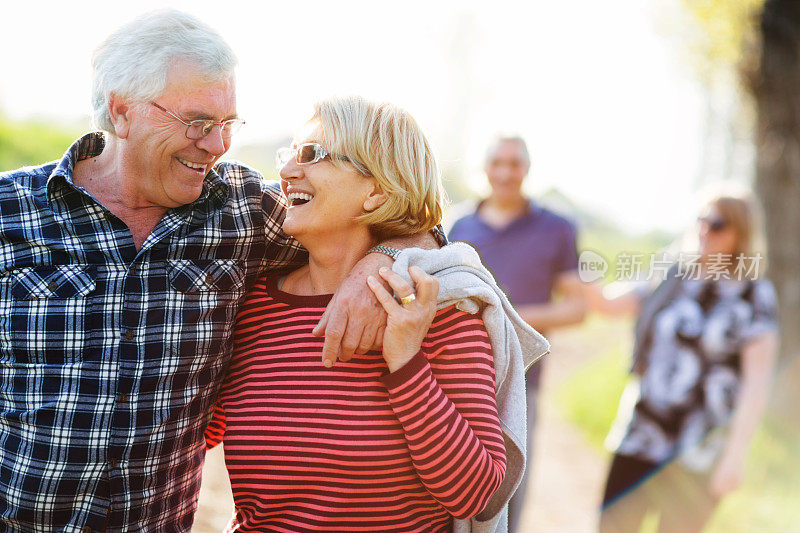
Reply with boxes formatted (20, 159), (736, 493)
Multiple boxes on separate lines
(367, 266), (439, 372)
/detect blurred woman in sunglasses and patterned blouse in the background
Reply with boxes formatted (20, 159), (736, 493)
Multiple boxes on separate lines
(588, 194), (778, 533)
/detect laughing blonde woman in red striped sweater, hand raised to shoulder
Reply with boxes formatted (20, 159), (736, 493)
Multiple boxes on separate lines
(206, 98), (505, 532)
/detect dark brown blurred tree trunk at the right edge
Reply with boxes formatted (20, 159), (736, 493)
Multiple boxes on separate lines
(748, 0), (800, 409)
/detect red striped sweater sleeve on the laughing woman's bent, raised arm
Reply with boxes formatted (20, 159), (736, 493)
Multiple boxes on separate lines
(382, 307), (506, 518)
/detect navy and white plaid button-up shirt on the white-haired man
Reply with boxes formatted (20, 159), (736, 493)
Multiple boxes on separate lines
(0, 133), (305, 532)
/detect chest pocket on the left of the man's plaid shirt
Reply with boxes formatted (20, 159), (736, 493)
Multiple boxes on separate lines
(0, 264), (96, 364)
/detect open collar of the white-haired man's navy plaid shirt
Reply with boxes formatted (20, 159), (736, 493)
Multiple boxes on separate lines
(47, 131), (230, 208)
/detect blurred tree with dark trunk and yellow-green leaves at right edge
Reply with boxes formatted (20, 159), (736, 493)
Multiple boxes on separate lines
(680, 0), (800, 390)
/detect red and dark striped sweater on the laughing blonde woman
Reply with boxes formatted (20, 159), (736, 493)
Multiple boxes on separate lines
(206, 278), (505, 532)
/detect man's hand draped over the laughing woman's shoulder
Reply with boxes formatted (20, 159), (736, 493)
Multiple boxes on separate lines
(313, 253), (392, 367)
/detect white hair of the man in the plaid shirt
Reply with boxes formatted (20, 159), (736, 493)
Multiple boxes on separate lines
(92, 9), (236, 133)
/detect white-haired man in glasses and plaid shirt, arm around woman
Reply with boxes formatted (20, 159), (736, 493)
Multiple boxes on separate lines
(0, 11), (444, 532)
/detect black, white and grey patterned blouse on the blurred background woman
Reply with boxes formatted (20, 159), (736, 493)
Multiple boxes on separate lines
(609, 279), (777, 471)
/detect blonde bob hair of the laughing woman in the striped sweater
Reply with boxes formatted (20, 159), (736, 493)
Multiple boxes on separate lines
(308, 96), (444, 238)
